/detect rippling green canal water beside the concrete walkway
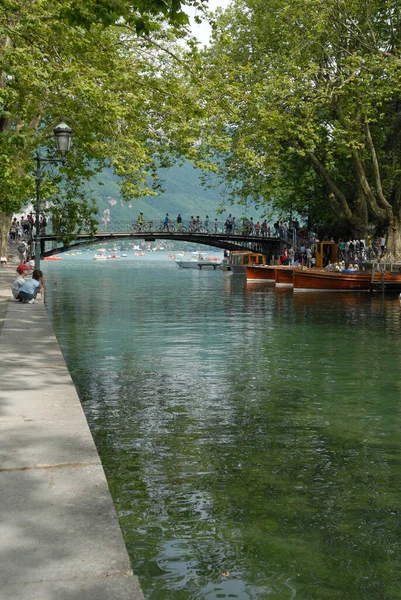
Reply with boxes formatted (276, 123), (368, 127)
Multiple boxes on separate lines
(45, 256), (401, 600)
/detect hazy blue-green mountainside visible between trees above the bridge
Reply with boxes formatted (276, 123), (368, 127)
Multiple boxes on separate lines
(90, 162), (234, 226)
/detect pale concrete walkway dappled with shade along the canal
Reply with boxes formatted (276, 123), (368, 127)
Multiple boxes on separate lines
(0, 255), (143, 600)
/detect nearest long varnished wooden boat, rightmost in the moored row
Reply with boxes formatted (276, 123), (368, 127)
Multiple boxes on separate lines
(293, 269), (401, 292)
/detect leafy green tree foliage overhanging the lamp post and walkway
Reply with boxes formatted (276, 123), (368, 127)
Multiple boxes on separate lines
(0, 0), (203, 254)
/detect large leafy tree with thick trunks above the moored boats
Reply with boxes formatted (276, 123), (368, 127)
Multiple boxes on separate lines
(194, 0), (401, 256)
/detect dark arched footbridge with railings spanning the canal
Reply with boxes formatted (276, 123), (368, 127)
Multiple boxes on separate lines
(41, 223), (293, 260)
